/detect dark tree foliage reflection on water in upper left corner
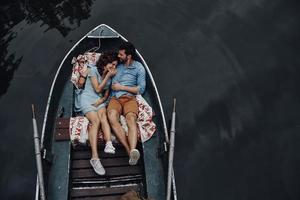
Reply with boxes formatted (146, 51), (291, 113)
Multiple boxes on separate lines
(0, 0), (93, 97)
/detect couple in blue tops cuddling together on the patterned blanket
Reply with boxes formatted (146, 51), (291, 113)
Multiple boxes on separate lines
(75, 42), (146, 175)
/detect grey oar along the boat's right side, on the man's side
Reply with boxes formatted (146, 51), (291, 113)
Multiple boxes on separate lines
(167, 99), (177, 200)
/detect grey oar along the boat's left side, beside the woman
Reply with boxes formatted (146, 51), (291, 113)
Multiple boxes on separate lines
(31, 104), (46, 200)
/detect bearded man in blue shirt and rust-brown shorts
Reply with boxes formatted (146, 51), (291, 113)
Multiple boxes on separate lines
(107, 42), (146, 165)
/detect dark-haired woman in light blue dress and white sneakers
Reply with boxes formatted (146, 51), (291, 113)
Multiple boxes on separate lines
(80, 52), (118, 175)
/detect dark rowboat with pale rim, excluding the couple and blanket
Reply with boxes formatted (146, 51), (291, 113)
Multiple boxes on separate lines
(35, 24), (177, 200)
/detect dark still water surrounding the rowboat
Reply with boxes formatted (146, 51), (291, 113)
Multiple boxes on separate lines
(0, 0), (300, 200)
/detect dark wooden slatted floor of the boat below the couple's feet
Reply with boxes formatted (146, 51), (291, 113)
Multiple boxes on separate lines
(70, 143), (145, 200)
